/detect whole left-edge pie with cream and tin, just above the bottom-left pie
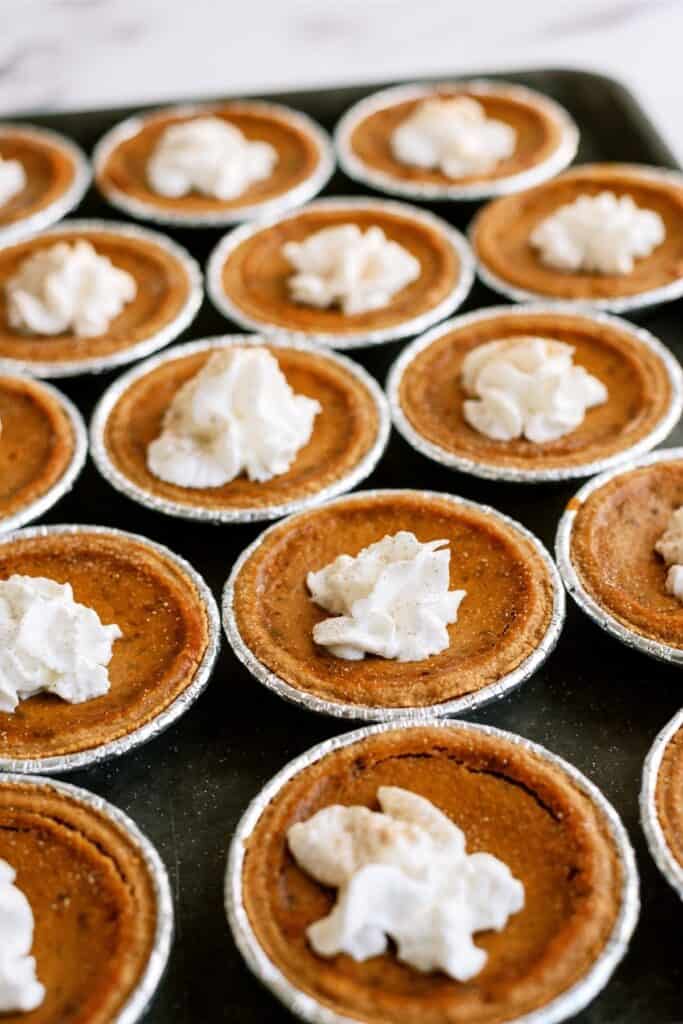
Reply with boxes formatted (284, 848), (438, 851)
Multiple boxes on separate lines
(0, 526), (218, 771)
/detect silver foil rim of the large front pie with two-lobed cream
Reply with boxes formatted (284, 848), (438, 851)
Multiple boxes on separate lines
(224, 716), (640, 1024)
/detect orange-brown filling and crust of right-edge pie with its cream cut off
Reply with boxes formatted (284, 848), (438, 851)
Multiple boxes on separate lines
(571, 462), (683, 647)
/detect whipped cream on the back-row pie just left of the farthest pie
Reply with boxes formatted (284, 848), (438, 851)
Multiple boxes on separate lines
(147, 117), (278, 200)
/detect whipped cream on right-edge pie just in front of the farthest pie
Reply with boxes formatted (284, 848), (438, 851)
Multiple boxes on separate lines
(529, 191), (667, 274)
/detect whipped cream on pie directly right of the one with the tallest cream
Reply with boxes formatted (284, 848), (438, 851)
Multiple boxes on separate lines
(462, 337), (607, 444)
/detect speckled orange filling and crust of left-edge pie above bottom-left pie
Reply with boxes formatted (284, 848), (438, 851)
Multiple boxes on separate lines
(0, 534), (208, 758)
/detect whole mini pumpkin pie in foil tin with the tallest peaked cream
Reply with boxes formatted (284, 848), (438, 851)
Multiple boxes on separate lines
(91, 335), (389, 522)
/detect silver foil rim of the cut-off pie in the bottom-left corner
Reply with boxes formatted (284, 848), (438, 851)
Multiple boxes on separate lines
(0, 773), (174, 1024)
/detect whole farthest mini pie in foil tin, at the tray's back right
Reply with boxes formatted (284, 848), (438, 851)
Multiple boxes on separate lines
(335, 80), (579, 201)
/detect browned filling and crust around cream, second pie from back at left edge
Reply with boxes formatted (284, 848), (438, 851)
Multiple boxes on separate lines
(0, 228), (190, 362)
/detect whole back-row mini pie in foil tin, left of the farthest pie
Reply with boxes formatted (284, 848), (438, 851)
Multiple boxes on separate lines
(93, 100), (334, 227)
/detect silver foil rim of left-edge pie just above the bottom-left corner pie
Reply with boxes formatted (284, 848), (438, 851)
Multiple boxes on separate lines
(0, 524), (220, 770)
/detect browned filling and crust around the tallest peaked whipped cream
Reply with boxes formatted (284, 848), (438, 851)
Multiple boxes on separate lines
(104, 345), (379, 509)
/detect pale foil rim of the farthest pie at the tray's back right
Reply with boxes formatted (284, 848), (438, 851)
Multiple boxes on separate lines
(334, 78), (579, 202)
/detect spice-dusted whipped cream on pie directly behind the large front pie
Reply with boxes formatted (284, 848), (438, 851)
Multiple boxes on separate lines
(306, 530), (466, 662)
